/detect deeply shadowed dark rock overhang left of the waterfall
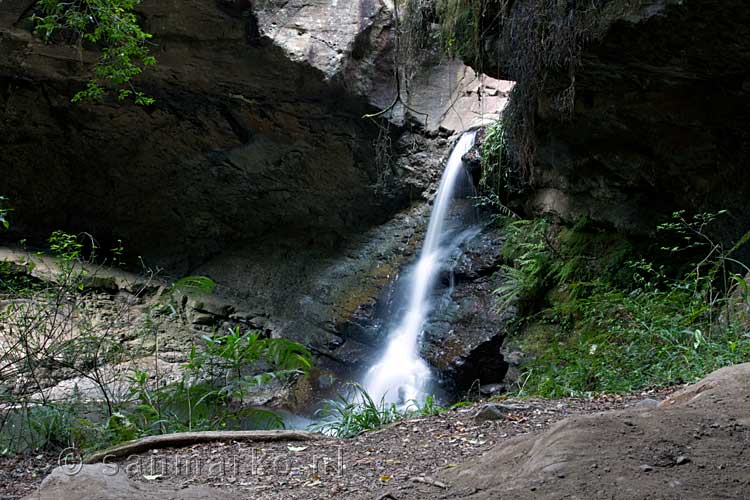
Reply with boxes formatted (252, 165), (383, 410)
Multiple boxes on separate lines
(0, 1), (412, 268)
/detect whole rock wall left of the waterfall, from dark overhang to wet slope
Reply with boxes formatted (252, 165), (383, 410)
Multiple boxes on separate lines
(0, 0), (507, 378)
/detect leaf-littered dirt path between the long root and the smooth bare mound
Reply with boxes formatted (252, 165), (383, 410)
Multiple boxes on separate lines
(0, 391), (669, 500)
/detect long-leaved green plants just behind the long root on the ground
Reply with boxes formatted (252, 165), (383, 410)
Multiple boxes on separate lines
(115, 327), (312, 439)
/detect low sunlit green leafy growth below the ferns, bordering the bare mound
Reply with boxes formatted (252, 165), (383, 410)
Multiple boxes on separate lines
(524, 285), (750, 397)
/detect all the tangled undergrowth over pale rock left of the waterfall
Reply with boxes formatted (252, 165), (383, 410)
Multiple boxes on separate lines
(0, 222), (312, 453)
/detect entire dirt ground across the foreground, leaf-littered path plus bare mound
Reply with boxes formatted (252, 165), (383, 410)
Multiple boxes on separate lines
(13, 364), (750, 500)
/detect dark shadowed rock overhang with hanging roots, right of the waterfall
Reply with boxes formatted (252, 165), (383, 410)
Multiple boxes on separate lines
(464, 0), (750, 241)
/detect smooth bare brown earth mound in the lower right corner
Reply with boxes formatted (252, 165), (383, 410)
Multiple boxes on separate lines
(439, 364), (750, 500)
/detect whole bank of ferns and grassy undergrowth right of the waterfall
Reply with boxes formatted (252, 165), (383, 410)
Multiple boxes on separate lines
(495, 212), (750, 397)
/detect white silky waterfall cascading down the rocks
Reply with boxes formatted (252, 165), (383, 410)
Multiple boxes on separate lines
(363, 131), (476, 404)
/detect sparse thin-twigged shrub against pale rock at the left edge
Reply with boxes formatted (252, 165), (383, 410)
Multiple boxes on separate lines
(0, 231), (132, 422)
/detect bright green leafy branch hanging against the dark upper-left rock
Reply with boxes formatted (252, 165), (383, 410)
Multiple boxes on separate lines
(34, 0), (156, 106)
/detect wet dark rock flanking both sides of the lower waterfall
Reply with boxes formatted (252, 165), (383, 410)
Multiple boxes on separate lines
(332, 224), (516, 396)
